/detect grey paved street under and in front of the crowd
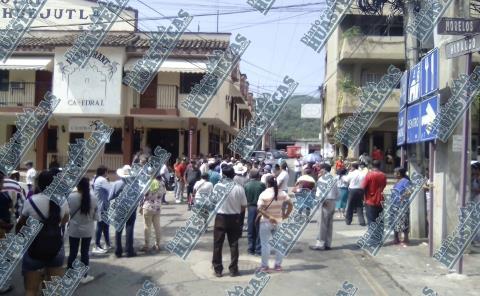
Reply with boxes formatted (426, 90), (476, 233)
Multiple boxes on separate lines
(4, 193), (480, 296)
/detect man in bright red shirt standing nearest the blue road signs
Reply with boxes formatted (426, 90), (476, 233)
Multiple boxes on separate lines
(362, 160), (387, 224)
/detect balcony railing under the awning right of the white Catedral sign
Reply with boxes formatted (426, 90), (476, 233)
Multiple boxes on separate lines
(132, 84), (178, 109)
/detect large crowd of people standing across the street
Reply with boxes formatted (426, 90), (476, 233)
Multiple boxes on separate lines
(0, 149), (480, 295)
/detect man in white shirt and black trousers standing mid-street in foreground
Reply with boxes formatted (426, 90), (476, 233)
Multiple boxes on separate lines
(212, 165), (247, 277)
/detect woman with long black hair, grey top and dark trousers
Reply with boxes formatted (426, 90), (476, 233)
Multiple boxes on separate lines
(68, 177), (98, 284)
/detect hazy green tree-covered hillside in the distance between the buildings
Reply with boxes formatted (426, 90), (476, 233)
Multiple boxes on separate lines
(274, 96), (321, 140)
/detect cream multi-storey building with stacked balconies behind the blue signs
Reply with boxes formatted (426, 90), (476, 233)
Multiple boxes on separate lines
(324, 8), (405, 157)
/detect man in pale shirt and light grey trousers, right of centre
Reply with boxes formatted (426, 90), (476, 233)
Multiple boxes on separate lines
(310, 163), (339, 251)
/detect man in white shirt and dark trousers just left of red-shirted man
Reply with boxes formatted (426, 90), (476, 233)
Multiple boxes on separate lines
(342, 162), (366, 226)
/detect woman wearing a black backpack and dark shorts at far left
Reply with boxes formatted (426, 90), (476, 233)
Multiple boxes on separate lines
(15, 171), (69, 296)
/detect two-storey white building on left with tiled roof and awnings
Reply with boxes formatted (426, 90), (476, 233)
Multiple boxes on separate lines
(0, 1), (252, 169)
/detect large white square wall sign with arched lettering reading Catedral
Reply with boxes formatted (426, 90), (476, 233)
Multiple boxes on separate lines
(53, 47), (125, 116)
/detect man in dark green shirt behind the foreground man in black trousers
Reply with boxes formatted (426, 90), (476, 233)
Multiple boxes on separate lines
(245, 169), (266, 256)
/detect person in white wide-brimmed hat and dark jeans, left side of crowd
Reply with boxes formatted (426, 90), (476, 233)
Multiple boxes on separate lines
(108, 164), (137, 258)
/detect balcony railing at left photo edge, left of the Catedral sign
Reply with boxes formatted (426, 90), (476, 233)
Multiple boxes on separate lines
(0, 81), (35, 107)
